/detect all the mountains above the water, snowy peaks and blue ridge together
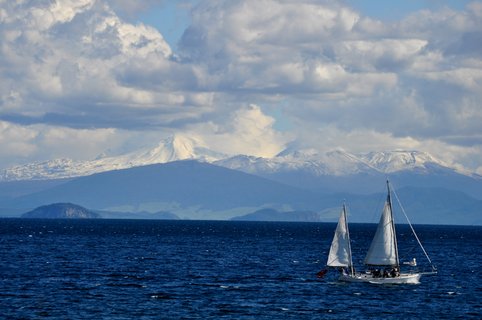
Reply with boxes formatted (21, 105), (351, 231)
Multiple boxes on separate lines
(0, 136), (482, 224)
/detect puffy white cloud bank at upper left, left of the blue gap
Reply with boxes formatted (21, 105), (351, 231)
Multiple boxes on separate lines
(0, 0), (199, 128)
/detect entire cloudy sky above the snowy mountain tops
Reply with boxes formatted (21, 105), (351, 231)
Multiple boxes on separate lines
(0, 0), (482, 174)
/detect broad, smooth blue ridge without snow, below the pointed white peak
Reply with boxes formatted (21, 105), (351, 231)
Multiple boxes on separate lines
(4, 160), (320, 219)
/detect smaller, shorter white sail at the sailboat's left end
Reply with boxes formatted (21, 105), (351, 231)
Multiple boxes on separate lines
(326, 207), (352, 267)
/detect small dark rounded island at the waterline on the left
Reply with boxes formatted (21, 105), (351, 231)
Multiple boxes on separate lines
(21, 203), (100, 219)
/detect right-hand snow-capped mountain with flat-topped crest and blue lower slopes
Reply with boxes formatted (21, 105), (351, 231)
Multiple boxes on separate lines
(214, 150), (482, 197)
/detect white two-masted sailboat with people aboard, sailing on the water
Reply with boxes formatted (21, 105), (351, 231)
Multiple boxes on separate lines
(327, 180), (437, 284)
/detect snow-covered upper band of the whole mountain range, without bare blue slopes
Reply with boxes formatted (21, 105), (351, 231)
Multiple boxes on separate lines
(0, 135), (470, 181)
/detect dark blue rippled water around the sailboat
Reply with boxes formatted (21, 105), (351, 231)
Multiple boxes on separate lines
(0, 219), (482, 319)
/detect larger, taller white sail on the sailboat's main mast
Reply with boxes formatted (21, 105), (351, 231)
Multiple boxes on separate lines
(365, 197), (399, 266)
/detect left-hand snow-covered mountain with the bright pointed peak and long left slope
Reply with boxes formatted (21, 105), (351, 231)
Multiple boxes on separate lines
(0, 135), (226, 181)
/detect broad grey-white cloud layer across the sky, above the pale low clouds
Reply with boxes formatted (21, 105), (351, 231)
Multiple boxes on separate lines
(0, 0), (482, 171)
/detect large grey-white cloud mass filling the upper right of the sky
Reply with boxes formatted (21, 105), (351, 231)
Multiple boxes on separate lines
(175, 1), (481, 152)
